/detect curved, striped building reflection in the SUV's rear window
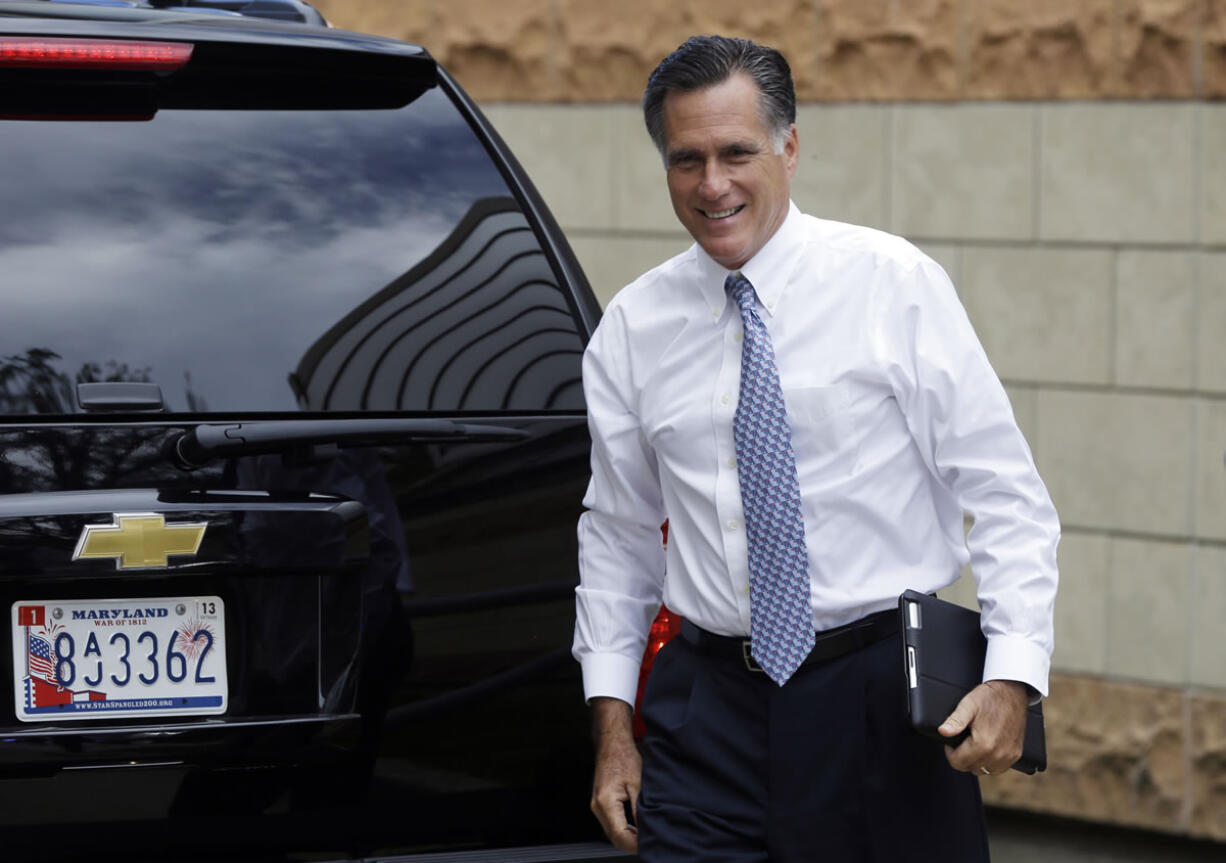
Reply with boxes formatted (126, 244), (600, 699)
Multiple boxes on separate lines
(292, 197), (582, 411)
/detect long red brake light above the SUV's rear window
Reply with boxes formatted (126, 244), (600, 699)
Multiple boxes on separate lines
(0, 36), (194, 72)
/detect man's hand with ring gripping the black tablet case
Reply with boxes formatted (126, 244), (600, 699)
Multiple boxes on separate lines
(938, 680), (1030, 775)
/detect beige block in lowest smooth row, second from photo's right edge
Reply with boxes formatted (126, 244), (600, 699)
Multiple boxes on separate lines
(1107, 538), (1193, 686)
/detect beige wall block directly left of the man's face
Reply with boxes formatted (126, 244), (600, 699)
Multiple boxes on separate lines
(613, 105), (684, 232)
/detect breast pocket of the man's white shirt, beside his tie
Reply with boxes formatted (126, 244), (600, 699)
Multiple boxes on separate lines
(783, 385), (859, 483)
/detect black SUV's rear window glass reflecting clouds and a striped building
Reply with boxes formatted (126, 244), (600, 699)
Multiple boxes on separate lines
(0, 89), (582, 413)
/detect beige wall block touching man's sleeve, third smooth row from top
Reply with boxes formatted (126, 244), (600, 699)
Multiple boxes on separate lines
(1036, 390), (1193, 537)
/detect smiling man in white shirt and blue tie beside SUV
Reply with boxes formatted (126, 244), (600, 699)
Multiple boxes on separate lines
(575, 37), (1059, 863)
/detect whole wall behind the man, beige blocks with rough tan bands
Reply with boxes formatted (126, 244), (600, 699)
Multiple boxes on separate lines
(316, 0), (1226, 841)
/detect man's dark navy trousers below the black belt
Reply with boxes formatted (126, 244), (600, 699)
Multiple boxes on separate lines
(638, 635), (988, 863)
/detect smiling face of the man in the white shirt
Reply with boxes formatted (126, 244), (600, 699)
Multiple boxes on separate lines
(663, 72), (799, 270)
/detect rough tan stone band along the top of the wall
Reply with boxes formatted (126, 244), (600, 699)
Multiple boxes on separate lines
(315, 0), (1226, 102)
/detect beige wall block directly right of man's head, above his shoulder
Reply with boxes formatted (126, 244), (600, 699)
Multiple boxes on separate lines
(792, 105), (890, 228)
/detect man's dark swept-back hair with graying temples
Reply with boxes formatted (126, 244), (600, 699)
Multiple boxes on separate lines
(642, 36), (796, 154)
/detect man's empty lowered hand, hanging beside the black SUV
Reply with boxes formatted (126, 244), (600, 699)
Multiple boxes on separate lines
(592, 699), (642, 853)
